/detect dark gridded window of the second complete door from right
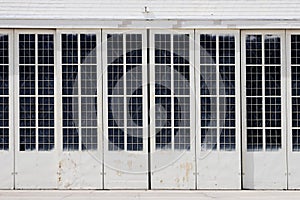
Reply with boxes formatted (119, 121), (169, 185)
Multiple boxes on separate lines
(199, 34), (236, 151)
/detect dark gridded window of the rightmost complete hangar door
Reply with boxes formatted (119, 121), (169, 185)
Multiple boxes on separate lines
(246, 34), (282, 151)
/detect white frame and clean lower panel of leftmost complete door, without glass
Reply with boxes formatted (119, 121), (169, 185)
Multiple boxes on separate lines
(13, 30), (59, 189)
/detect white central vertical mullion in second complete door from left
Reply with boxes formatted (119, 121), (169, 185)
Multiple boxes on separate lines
(77, 33), (82, 151)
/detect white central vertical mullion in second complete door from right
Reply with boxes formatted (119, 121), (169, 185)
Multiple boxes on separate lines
(216, 34), (220, 151)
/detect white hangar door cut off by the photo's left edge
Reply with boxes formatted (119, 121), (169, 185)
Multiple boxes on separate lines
(0, 30), (14, 189)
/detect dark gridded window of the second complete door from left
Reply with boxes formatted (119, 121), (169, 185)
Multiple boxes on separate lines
(61, 33), (98, 151)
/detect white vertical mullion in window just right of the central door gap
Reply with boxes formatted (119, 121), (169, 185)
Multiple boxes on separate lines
(170, 33), (175, 150)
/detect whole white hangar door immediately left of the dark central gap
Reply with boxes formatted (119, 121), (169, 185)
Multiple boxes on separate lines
(102, 30), (148, 189)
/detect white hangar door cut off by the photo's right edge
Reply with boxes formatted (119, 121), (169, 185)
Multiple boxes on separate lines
(286, 31), (300, 189)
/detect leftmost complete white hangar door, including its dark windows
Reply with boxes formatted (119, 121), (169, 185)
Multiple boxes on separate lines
(14, 30), (58, 189)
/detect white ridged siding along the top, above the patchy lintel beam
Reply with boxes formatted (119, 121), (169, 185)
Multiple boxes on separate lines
(0, 0), (300, 19)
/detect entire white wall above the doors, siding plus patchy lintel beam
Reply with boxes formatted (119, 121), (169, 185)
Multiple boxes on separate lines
(0, 0), (300, 28)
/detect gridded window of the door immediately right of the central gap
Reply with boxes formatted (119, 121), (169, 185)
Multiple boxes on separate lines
(154, 34), (191, 151)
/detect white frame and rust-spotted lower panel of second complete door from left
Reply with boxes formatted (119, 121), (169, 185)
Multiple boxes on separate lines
(56, 29), (103, 189)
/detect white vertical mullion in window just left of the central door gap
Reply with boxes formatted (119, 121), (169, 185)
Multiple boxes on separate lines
(122, 34), (127, 151)
